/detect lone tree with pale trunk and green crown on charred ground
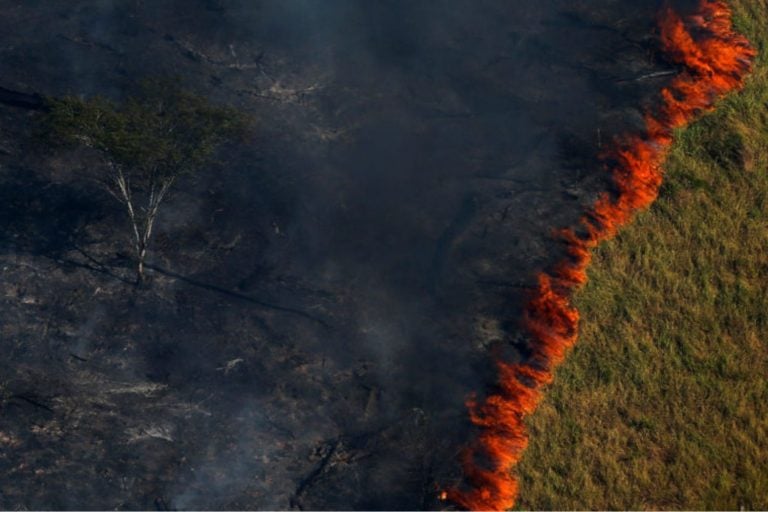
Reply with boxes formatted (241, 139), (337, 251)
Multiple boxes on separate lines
(47, 79), (247, 282)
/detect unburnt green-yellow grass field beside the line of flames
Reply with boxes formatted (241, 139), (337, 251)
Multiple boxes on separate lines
(518, 0), (768, 509)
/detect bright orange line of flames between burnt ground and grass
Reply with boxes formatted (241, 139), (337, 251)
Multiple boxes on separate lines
(450, 0), (756, 510)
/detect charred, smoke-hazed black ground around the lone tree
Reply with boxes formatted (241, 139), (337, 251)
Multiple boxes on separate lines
(0, 0), (674, 509)
